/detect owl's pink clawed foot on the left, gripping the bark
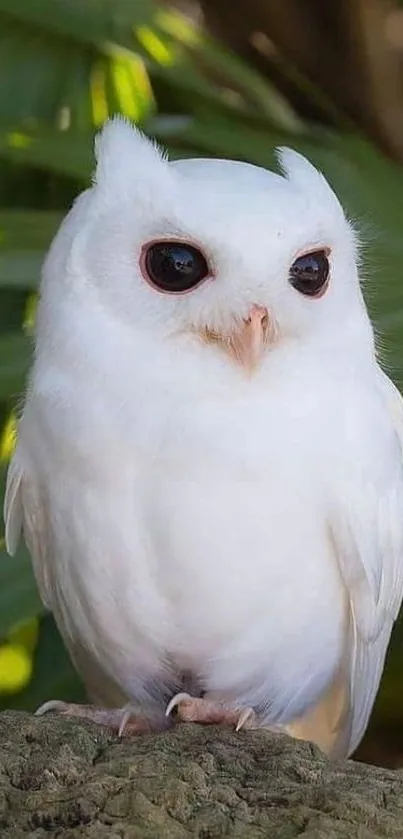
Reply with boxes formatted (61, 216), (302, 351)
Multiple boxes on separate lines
(35, 699), (157, 737)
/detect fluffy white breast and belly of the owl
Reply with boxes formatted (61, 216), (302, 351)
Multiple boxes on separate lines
(35, 354), (345, 719)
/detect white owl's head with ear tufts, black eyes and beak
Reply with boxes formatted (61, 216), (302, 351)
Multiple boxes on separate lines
(48, 119), (376, 369)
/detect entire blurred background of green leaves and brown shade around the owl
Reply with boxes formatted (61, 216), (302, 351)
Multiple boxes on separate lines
(0, 0), (403, 765)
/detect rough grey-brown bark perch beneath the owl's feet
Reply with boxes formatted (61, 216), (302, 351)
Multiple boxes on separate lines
(0, 712), (403, 839)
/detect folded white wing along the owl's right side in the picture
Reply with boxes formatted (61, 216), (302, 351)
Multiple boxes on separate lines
(330, 369), (403, 754)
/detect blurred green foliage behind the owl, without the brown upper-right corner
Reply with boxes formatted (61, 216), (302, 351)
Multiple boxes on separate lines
(0, 0), (403, 756)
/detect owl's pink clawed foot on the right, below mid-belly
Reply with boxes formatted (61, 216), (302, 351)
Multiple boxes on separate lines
(165, 693), (256, 731)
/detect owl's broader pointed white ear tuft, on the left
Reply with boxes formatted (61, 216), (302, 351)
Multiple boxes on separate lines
(94, 116), (165, 186)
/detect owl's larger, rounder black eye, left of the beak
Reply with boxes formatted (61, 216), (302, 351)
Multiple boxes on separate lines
(143, 242), (209, 294)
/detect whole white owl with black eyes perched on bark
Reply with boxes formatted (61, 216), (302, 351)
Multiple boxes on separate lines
(5, 120), (403, 757)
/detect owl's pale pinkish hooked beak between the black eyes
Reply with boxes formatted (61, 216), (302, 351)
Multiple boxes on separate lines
(202, 306), (274, 372)
